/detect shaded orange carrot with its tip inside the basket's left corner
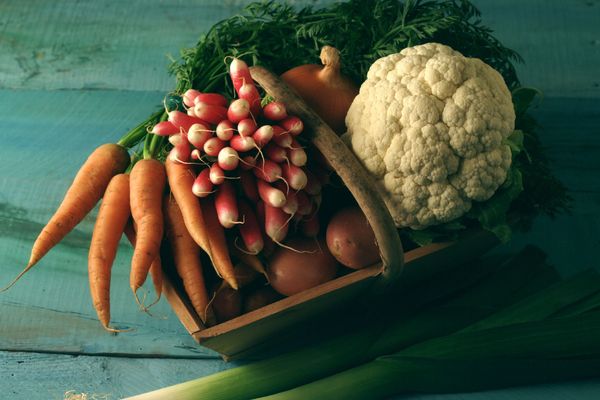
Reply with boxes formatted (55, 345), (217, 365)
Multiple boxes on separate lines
(164, 197), (210, 322)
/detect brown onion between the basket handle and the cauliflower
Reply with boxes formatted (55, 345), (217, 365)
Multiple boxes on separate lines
(281, 46), (359, 135)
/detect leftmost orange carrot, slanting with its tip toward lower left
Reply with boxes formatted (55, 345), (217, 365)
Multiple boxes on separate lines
(0, 143), (129, 291)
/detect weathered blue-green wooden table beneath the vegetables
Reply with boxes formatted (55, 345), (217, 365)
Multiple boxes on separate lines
(0, 0), (600, 399)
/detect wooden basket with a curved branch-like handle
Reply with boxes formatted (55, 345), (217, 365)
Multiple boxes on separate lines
(159, 67), (497, 359)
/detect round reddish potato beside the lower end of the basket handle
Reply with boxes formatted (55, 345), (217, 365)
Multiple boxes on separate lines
(326, 206), (380, 269)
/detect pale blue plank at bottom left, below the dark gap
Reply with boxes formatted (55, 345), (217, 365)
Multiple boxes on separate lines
(0, 352), (235, 400)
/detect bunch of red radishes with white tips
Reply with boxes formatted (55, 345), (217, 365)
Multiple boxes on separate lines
(152, 59), (321, 254)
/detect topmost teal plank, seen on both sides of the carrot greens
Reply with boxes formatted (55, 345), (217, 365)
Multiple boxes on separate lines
(0, 0), (600, 97)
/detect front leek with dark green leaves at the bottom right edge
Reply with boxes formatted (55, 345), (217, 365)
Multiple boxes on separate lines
(262, 312), (600, 400)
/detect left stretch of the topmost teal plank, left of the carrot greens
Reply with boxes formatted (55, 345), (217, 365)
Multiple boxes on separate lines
(0, 0), (246, 91)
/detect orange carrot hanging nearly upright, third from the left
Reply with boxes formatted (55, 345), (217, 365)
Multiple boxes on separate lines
(129, 159), (166, 302)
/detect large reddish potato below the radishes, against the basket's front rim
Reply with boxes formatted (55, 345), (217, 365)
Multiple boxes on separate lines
(267, 237), (338, 296)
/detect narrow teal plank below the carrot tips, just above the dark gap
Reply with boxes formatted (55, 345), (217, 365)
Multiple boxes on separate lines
(0, 302), (220, 359)
